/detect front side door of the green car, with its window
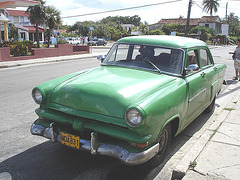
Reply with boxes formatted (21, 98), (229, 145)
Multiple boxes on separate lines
(185, 48), (208, 123)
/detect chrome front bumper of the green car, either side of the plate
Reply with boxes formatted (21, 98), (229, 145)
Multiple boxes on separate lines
(30, 123), (159, 165)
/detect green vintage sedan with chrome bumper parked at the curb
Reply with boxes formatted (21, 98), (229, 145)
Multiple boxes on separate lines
(31, 36), (226, 165)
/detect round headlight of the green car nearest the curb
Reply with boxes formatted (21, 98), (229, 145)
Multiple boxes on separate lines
(125, 109), (142, 127)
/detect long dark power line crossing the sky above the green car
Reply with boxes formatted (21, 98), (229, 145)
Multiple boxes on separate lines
(62, 0), (182, 18)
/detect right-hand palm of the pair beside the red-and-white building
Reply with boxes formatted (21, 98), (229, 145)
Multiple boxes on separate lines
(45, 6), (61, 48)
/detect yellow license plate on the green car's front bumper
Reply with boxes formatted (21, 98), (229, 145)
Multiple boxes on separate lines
(61, 132), (80, 149)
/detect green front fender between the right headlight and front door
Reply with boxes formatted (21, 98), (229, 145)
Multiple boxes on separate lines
(133, 78), (187, 146)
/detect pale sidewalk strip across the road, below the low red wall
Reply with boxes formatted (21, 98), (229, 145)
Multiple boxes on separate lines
(0, 54), (98, 68)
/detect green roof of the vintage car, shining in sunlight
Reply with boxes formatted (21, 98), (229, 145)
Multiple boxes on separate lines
(117, 35), (207, 48)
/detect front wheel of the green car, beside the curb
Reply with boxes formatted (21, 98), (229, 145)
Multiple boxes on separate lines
(145, 123), (172, 168)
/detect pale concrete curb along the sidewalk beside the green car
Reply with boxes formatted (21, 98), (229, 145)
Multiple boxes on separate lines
(171, 82), (239, 179)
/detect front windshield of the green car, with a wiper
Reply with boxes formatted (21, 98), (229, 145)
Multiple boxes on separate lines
(103, 43), (184, 74)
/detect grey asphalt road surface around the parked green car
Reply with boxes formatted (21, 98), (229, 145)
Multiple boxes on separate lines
(0, 46), (235, 180)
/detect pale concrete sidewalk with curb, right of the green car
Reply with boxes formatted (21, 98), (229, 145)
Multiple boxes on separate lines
(172, 81), (240, 180)
